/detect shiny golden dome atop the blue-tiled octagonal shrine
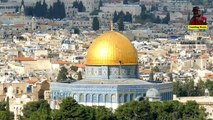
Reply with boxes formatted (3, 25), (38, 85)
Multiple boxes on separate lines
(85, 31), (138, 65)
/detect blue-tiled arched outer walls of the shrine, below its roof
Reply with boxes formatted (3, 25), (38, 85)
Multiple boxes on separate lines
(51, 83), (173, 103)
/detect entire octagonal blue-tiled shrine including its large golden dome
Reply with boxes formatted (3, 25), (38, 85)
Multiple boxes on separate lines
(50, 31), (173, 109)
